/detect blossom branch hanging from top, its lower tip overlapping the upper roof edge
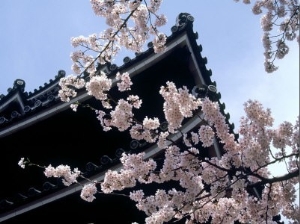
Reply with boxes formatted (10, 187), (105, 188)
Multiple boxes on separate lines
(59, 0), (167, 107)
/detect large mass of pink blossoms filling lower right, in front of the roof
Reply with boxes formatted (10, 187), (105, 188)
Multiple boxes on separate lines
(50, 76), (299, 223)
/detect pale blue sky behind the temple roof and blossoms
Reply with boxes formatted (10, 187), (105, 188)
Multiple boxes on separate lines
(0, 0), (299, 221)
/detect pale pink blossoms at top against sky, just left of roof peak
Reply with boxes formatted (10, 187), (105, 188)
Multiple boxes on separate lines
(71, 0), (167, 74)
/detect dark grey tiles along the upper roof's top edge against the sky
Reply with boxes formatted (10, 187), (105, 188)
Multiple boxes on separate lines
(0, 13), (219, 138)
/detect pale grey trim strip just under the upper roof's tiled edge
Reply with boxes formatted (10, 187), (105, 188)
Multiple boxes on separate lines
(0, 25), (211, 138)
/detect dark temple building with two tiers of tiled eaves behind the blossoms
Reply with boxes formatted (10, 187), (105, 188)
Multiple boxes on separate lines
(0, 13), (233, 224)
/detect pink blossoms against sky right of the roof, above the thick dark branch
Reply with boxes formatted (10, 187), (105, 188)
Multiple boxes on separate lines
(238, 101), (299, 177)
